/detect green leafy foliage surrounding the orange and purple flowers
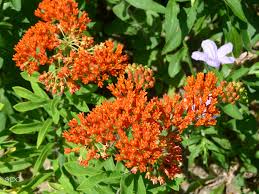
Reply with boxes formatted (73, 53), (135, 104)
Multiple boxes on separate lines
(0, 0), (259, 194)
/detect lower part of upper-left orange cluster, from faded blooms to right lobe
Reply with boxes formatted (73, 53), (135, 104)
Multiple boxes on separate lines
(39, 39), (127, 94)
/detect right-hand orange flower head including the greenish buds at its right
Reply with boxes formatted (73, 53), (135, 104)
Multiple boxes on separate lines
(166, 72), (245, 133)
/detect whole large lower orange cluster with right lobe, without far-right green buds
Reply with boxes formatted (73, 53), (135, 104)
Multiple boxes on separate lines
(63, 69), (242, 184)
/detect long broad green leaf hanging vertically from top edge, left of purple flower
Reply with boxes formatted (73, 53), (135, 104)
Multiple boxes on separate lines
(162, 0), (182, 54)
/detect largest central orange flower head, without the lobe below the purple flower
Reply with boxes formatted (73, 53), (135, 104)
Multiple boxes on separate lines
(63, 64), (182, 184)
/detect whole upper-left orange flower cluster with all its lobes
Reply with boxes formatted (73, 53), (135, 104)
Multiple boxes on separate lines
(13, 0), (127, 94)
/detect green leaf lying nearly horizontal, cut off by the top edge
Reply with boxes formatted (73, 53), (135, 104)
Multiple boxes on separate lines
(126, 0), (165, 13)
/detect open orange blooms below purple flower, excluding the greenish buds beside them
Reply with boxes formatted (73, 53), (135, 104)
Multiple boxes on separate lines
(181, 72), (223, 130)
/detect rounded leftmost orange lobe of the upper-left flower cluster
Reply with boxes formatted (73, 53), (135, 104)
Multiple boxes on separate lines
(13, 22), (59, 74)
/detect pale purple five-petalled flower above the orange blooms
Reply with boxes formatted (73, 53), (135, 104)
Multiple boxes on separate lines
(192, 40), (235, 68)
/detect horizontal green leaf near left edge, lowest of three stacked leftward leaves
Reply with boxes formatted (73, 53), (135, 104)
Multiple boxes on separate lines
(9, 122), (42, 134)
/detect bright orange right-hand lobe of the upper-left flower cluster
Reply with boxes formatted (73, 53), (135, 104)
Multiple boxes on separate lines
(71, 41), (127, 87)
